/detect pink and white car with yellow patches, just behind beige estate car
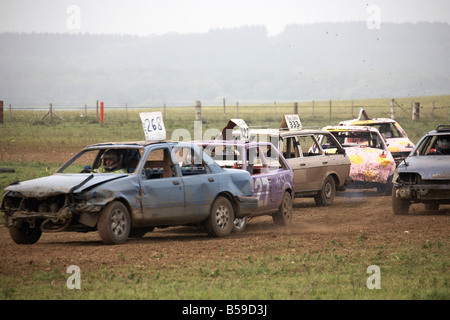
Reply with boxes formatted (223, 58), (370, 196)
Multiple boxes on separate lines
(320, 126), (396, 194)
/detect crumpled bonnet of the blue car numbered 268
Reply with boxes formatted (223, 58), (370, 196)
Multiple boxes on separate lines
(5, 173), (126, 198)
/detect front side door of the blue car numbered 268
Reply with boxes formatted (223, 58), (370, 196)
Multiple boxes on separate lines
(140, 146), (185, 224)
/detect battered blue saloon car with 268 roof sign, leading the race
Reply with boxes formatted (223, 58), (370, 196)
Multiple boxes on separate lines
(1, 141), (258, 244)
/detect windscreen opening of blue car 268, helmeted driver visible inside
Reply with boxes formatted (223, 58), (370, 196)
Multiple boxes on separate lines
(57, 147), (144, 173)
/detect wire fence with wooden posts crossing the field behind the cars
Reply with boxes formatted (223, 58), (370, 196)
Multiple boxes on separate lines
(0, 96), (450, 124)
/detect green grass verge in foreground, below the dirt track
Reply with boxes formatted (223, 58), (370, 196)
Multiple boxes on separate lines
(0, 239), (450, 300)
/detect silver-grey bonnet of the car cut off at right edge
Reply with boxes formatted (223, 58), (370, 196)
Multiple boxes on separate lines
(398, 155), (450, 180)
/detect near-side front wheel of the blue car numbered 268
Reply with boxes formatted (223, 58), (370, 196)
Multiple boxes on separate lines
(97, 201), (131, 244)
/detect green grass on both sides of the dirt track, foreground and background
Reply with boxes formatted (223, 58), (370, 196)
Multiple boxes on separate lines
(0, 96), (450, 300)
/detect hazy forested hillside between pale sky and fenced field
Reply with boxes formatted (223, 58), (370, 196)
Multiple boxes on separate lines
(0, 22), (450, 106)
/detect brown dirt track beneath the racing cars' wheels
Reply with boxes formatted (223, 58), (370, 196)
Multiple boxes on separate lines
(0, 191), (450, 275)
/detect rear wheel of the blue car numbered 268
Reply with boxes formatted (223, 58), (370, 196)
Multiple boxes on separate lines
(205, 197), (234, 237)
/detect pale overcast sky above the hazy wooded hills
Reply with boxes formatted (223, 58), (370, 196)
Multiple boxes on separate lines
(0, 0), (450, 36)
